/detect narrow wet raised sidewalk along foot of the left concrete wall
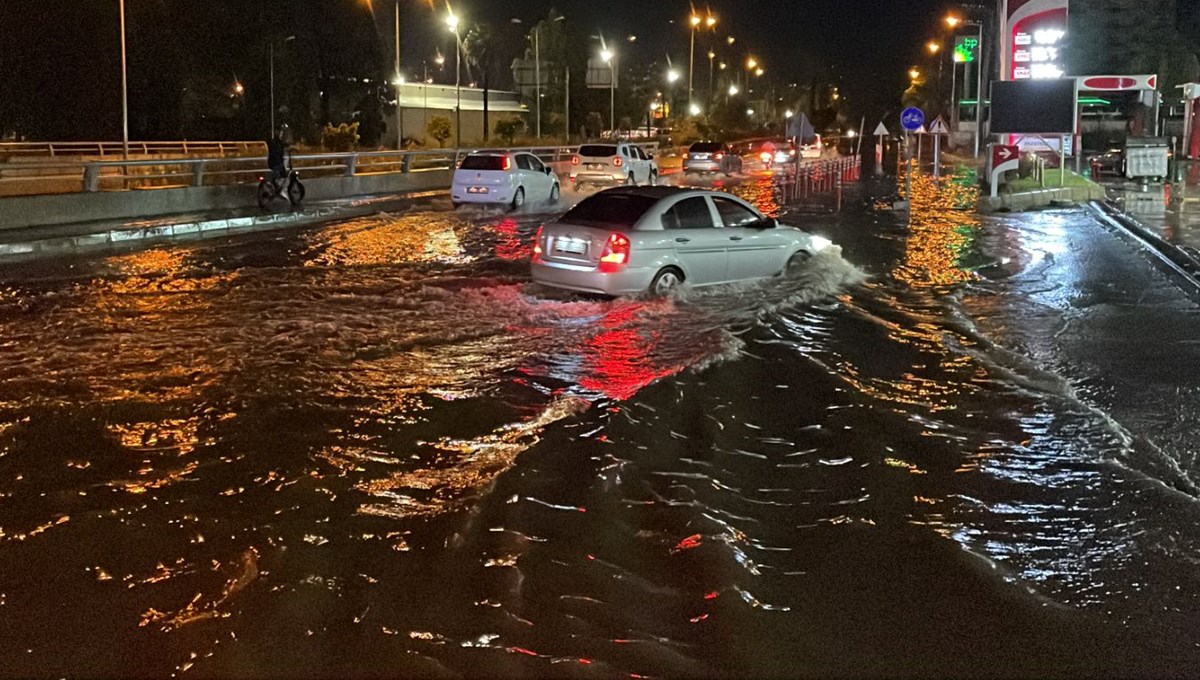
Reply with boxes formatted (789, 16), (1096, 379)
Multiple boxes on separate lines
(0, 192), (444, 263)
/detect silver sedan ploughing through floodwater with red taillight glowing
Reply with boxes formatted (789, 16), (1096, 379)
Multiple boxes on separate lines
(532, 187), (830, 295)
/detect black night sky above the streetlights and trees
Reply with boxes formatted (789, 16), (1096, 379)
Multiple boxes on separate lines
(0, 0), (947, 138)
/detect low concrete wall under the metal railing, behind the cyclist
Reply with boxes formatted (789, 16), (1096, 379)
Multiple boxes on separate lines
(0, 170), (451, 230)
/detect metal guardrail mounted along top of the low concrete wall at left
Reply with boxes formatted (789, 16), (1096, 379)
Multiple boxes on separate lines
(0, 143), (658, 197)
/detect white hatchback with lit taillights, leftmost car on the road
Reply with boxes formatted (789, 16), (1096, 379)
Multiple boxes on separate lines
(450, 150), (559, 210)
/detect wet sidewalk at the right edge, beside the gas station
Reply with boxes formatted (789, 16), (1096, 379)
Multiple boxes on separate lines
(1093, 166), (1200, 288)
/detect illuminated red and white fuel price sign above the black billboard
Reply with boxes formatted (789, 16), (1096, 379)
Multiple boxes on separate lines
(1001, 0), (1069, 80)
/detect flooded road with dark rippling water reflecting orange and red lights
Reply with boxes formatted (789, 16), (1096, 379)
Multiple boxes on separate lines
(0, 177), (1200, 678)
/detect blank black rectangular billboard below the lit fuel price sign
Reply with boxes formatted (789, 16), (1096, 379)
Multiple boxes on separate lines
(991, 78), (1078, 134)
